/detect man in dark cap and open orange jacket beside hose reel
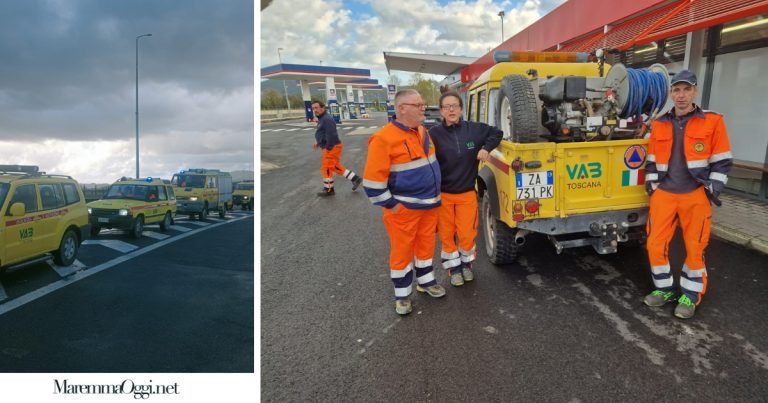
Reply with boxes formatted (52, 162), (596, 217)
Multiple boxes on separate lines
(644, 70), (733, 319)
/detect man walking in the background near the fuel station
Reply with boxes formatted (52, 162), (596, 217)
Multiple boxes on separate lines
(312, 101), (363, 197)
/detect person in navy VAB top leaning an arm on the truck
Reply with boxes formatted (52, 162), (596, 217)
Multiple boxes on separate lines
(429, 92), (504, 287)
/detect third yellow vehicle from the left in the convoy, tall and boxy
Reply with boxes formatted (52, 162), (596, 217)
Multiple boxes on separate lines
(171, 168), (232, 220)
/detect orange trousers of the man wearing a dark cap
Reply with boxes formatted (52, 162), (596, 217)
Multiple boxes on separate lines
(646, 187), (712, 305)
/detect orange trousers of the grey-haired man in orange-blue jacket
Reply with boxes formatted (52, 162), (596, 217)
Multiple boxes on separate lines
(384, 205), (437, 299)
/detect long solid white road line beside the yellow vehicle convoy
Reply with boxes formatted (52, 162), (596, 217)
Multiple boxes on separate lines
(0, 217), (254, 315)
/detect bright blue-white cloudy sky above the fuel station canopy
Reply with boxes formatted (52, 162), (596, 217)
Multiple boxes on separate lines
(260, 0), (565, 83)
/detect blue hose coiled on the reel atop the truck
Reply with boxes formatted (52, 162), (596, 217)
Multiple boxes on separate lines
(620, 68), (668, 118)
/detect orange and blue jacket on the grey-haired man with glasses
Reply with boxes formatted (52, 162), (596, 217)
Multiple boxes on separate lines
(363, 121), (440, 210)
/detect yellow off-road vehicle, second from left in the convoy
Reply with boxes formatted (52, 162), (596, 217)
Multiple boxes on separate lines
(88, 177), (176, 239)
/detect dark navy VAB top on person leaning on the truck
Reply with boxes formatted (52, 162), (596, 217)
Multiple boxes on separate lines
(429, 119), (504, 193)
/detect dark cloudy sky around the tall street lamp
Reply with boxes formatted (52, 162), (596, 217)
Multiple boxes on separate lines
(0, 0), (254, 183)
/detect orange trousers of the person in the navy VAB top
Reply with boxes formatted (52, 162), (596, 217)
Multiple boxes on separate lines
(437, 190), (477, 271)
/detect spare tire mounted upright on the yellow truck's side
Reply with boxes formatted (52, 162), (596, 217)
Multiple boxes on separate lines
(495, 74), (540, 143)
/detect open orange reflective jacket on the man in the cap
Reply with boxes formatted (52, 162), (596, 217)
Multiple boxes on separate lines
(645, 107), (733, 206)
